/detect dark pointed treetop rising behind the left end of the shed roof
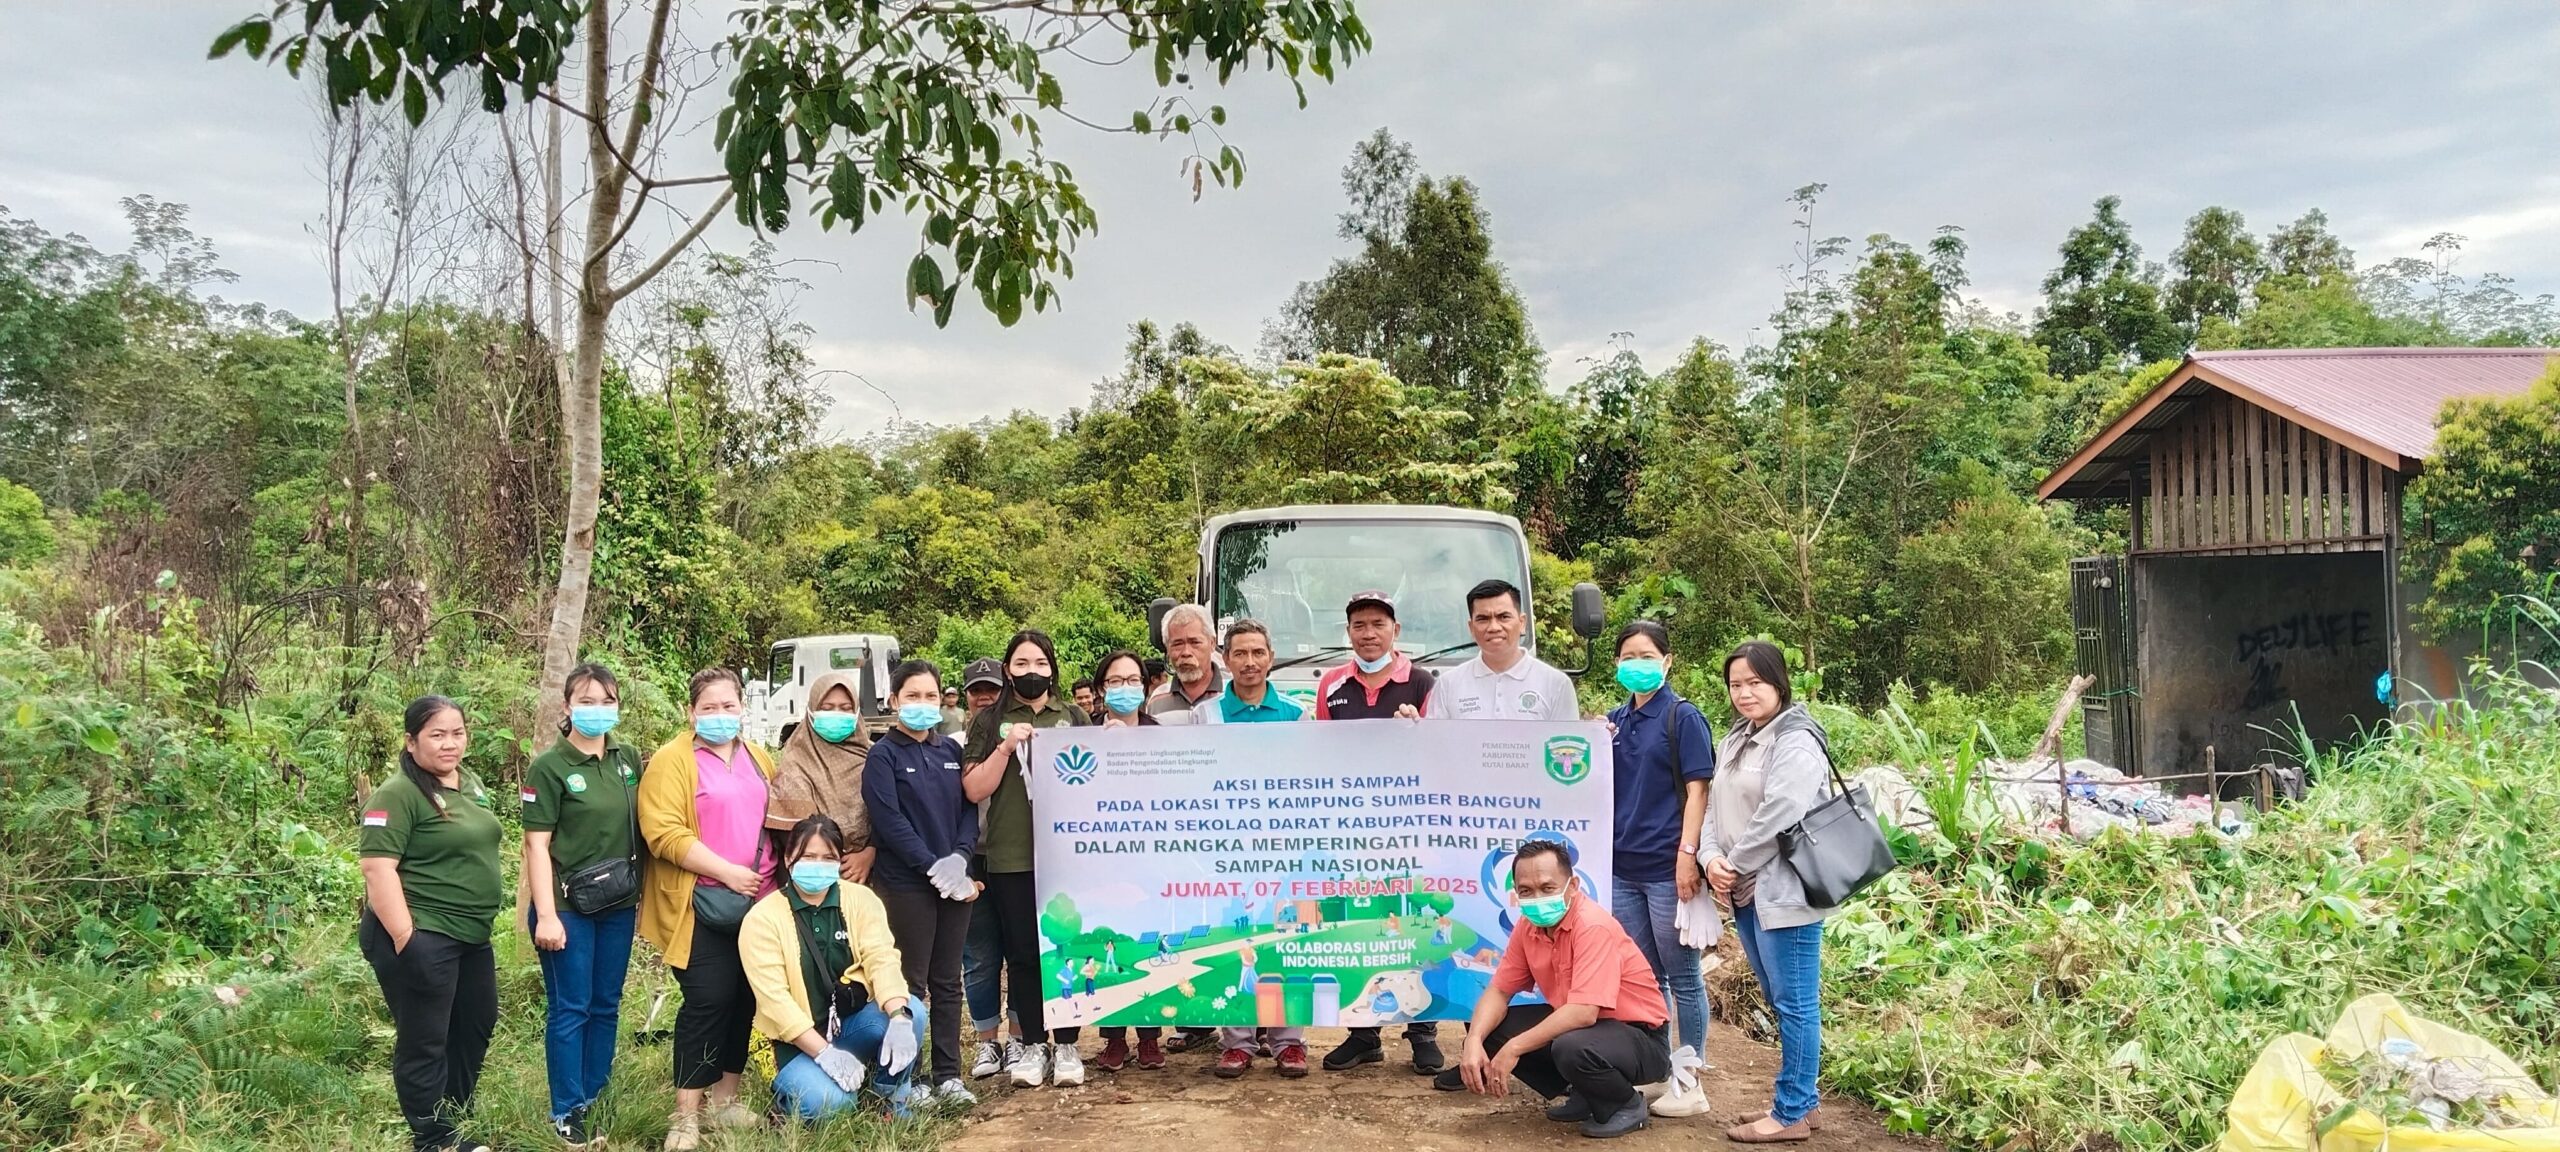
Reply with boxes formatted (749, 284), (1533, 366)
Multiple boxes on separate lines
(2035, 197), (2186, 376)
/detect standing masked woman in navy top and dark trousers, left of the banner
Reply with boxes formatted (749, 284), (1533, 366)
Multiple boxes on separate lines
(863, 660), (978, 1103)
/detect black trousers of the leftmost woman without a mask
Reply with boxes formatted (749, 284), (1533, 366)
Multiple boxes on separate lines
(356, 909), (497, 1149)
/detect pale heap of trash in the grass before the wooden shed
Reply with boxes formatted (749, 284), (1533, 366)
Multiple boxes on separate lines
(1851, 760), (2250, 840)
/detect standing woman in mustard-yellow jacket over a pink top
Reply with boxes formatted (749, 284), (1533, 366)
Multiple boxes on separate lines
(640, 668), (773, 1152)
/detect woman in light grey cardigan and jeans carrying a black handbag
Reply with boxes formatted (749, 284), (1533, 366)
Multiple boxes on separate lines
(1697, 640), (1836, 1144)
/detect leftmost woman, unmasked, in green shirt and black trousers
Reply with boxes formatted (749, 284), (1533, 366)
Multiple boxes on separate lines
(356, 696), (507, 1149)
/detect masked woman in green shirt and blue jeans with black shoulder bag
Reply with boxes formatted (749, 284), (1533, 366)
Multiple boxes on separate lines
(522, 663), (640, 1147)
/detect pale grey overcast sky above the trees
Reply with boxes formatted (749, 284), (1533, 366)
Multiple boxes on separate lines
(0, 0), (2560, 433)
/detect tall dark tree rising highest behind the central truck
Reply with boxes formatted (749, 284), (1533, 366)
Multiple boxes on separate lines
(1267, 128), (1544, 407)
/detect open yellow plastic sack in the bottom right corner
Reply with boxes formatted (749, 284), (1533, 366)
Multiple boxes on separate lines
(2222, 993), (2560, 1152)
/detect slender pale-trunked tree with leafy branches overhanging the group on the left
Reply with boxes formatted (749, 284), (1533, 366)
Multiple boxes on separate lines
(212, 0), (1370, 724)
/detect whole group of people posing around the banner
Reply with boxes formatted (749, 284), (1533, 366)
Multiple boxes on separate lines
(358, 581), (1830, 1152)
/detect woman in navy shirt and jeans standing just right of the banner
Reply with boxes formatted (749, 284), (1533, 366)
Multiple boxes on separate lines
(1608, 620), (1715, 1052)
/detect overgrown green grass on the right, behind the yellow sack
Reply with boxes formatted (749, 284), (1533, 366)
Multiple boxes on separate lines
(1823, 660), (2560, 1149)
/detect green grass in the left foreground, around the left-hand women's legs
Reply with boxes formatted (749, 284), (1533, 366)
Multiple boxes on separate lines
(0, 924), (960, 1152)
